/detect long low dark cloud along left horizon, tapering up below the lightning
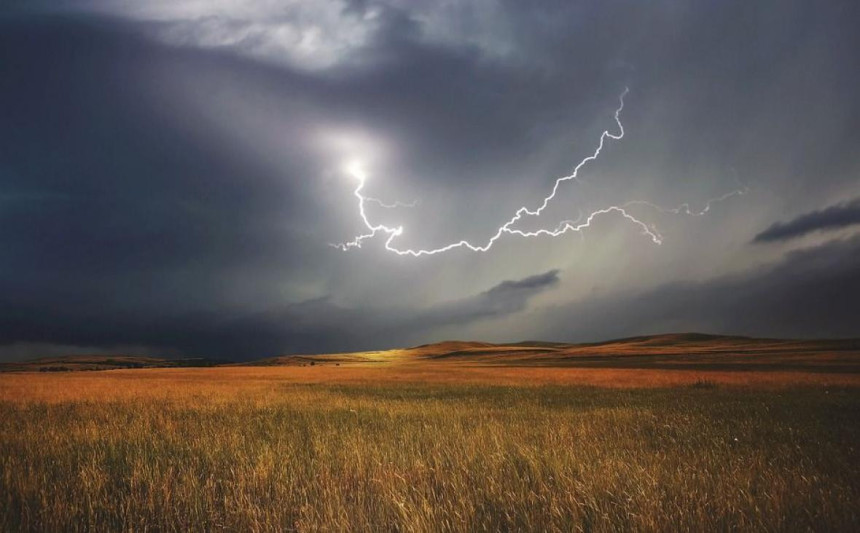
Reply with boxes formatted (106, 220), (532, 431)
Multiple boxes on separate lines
(0, 271), (559, 360)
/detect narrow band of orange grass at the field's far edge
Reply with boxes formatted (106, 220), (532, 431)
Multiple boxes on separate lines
(0, 363), (860, 403)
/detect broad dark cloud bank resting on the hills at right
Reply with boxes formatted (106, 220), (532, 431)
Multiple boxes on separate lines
(538, 237), (860, 340)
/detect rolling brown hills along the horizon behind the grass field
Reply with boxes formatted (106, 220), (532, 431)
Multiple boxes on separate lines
(6, 333), (860, 372)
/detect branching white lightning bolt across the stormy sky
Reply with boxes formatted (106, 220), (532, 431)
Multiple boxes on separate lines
(331, 87), (745, 257)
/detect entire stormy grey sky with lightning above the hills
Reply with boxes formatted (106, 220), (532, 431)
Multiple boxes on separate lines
(0, 0), (860, 361)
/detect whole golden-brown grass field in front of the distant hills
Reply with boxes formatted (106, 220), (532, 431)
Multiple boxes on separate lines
(0, 365), (860, 531)
